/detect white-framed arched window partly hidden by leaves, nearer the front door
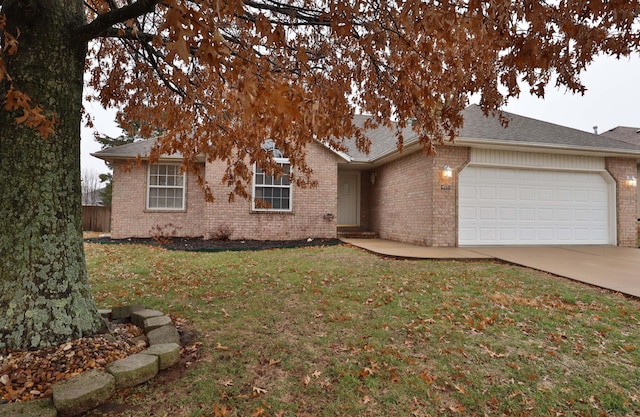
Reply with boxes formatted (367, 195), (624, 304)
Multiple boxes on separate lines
(253, 141), (292, 211)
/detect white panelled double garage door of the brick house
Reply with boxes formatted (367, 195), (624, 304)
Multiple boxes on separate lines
(458, 167), (609, 245)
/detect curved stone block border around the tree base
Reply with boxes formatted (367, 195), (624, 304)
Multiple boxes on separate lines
(0, 305), (180, 417)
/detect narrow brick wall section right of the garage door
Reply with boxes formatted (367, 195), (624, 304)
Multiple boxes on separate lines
(605, 158), (638, 247)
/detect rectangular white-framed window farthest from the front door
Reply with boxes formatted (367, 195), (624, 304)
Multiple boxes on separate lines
(147, 164), (185, 210)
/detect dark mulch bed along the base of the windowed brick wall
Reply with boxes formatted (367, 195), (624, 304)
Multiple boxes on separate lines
(85, 237), (341, 252)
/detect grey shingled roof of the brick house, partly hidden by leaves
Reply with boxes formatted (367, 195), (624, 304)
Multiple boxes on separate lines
(91, 104), (640, 164)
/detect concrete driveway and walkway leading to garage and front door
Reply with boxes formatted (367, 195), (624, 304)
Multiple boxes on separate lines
(342, 239), (640, 297)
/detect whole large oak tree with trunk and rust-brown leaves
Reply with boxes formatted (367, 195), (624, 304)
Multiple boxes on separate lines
(0, 0), (640, 348)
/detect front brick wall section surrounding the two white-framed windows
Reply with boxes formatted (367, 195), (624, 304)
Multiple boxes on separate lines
(111, 144), (338, 240)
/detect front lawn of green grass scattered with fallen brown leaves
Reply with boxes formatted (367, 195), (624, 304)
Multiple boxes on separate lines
(86, 244), (640, 416)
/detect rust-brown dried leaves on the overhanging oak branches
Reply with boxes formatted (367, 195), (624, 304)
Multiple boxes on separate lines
(0, 0), (640, 197)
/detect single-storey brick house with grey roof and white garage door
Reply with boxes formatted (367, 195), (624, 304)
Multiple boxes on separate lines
(93, 105), (640, 247)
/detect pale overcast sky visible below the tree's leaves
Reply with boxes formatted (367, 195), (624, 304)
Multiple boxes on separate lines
(81, 52), (640, 173)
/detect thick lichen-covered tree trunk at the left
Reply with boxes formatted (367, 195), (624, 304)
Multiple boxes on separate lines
(0, 0), (104, 349)
